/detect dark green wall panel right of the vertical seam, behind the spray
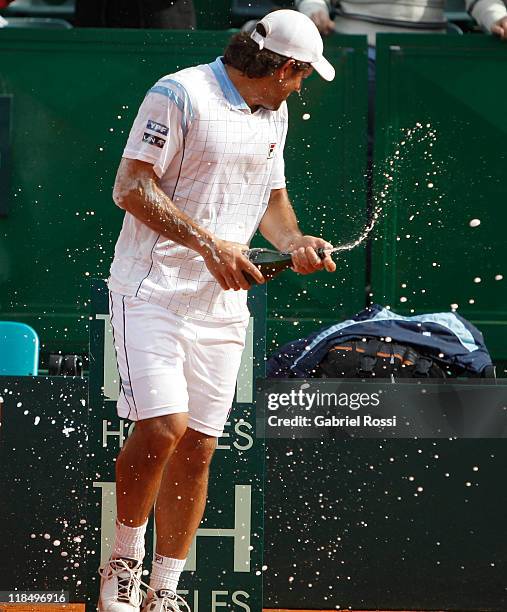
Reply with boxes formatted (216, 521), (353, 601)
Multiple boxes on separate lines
(373, 35), (507, 360)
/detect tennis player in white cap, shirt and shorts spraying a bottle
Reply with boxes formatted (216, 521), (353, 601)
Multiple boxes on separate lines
(99, 10), (336, 612)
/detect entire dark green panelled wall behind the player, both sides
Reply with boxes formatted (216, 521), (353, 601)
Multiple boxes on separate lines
(0, 30), (507, 366)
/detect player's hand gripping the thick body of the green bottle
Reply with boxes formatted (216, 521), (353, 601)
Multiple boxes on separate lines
(202, 238), (265, 291)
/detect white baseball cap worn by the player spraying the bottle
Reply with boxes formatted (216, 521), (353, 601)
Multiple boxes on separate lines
(251, 9), (335, 81)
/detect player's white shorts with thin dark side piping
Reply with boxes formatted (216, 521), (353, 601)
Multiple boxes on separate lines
(109, 292), (248, 437)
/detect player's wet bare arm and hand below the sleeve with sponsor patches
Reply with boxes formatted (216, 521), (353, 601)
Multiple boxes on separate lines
(113, 158), (263, 290)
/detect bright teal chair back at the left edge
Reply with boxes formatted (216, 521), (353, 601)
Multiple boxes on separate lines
(0, 321), (39, 376)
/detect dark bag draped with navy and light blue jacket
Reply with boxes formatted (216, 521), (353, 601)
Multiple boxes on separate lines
(267, 304), (495, 378)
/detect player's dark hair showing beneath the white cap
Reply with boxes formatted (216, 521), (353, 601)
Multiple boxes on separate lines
(224, 23), (311, 79)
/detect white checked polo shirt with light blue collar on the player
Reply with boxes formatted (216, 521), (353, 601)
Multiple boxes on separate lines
(109, 58), (288, 321)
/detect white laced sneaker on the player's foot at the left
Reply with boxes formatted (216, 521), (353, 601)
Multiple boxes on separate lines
(98, 558), (143, 612)
